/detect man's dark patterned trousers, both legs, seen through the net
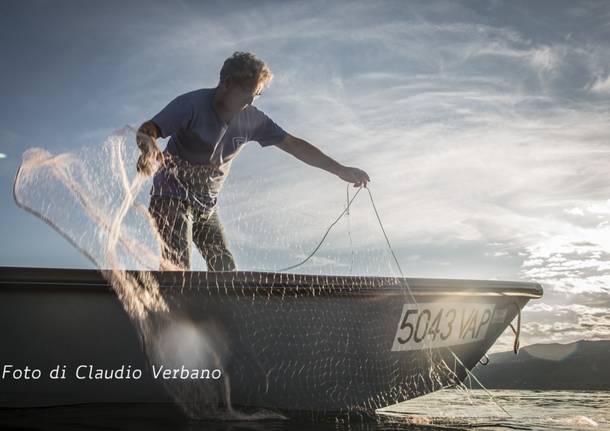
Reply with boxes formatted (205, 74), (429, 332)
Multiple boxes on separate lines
(149, 196), (237, 271)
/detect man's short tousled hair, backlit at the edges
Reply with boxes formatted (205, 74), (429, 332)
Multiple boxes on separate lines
(220, 51), (273, 92)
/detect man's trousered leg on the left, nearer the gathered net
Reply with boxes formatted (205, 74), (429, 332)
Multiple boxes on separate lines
(148, 196), (191, 271)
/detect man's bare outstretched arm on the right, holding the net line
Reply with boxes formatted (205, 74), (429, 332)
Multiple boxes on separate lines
(277, 133), (371, 187)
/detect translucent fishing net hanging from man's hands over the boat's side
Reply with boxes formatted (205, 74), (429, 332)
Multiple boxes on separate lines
(14, 127), (484, 419)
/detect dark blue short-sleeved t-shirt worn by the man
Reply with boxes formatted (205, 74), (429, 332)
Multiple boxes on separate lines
(151, 88), (286, 211)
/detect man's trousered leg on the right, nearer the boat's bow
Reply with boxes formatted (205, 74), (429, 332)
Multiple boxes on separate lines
(193, 210), (237, 271)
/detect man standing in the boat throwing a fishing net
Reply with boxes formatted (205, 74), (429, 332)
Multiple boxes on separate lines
(137, 52), (370, 271)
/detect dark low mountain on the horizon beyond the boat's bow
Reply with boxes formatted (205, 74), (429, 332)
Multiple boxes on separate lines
(473, 340), (610, 390)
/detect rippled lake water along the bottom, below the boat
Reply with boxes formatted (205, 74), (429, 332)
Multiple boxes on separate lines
(0, 389), (610, 431)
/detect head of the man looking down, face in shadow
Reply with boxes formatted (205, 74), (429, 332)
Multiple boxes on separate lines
(218, 52), (273, 112)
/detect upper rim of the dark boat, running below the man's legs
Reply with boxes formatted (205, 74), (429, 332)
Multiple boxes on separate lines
(0, 267), (543, 298)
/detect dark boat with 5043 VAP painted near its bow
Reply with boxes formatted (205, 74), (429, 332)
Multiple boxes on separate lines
(0, 267), (543, 413)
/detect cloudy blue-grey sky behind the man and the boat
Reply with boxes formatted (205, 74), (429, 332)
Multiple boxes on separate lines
(0, 0), (610, 348)
